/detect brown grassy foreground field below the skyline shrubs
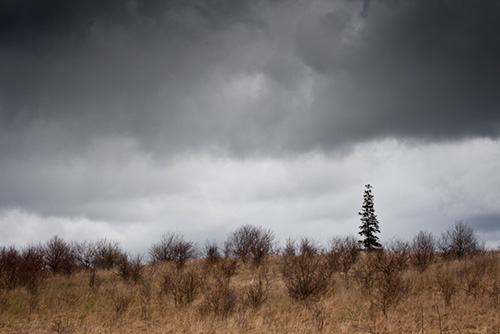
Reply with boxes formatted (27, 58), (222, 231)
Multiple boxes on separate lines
(0, 251), (500, 334)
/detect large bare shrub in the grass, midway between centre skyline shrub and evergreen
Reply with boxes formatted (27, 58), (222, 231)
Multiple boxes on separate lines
(281, 238), (332, 301)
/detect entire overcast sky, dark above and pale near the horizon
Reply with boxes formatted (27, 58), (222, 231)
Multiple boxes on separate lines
(0, 0), (500, 252)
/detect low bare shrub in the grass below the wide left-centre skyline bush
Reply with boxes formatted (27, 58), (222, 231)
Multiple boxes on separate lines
(161, 268), (202, 306)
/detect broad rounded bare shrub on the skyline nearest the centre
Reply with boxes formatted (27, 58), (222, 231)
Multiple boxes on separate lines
(226, 225), (274, 267)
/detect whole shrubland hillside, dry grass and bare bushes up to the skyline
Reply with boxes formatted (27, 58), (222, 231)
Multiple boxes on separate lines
(0, 225), (500, 333)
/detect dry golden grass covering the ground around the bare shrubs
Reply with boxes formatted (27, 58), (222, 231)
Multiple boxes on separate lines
(0, 252), (500, 334)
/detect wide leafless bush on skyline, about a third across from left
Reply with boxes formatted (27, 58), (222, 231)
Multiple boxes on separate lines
(149, 233), (196, 269)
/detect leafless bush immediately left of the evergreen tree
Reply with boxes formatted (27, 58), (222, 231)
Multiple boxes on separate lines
(328, 236), (361, 281)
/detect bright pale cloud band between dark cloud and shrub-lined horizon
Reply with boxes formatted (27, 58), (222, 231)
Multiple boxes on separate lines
(0, 139), (500, 251)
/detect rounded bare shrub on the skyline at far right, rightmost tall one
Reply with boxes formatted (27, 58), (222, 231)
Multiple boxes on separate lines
(438, 221), (482, 259)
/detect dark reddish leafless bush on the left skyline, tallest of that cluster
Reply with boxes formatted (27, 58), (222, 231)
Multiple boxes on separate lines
(43, 235), (76, 276)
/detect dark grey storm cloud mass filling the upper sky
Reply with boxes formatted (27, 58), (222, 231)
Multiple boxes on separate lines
(0, 0), (500, 155)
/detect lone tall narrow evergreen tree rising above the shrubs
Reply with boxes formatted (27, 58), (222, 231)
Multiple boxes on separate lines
(358, 184), (382, 250)
